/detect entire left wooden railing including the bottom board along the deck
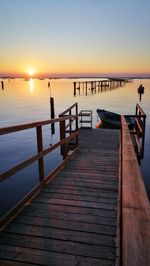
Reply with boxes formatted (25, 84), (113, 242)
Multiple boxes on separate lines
(0, 113), (78, 226)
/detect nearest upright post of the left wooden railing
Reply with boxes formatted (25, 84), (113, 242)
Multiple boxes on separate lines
(36, 126), (44, 182)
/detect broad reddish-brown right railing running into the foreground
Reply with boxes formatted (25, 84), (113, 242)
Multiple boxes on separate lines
(121, 116), (150, 266)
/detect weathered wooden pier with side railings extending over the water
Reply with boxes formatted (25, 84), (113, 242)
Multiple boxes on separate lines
(0, 104), (150, 266)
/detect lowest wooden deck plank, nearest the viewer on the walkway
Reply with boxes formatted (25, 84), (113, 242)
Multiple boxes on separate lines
(0, 245), (114, 266)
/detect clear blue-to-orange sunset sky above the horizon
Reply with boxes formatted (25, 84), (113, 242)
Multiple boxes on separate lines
(0, 0), (150, 76)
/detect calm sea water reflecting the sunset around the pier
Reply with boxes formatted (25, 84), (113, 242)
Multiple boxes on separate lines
(0, 79), (150, 216)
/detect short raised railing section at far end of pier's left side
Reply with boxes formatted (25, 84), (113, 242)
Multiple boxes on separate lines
(59, 103), (78, 156)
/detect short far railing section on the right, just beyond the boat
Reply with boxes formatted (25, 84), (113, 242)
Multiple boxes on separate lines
(125, 104), (146, 161)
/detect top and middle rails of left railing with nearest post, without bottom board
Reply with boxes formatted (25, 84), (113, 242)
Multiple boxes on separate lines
(0, 112), (78, 182)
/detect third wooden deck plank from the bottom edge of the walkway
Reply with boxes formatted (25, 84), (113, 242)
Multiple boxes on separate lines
(0, 224), (115, 247)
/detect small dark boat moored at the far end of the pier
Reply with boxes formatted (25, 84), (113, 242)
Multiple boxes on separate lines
(97, 109), (134, 128)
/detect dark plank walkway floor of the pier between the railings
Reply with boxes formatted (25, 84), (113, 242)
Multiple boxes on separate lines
(0, 129), (119, 266)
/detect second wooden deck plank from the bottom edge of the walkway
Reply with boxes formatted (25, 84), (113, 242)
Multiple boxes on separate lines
(0, 234), (115, 260)
